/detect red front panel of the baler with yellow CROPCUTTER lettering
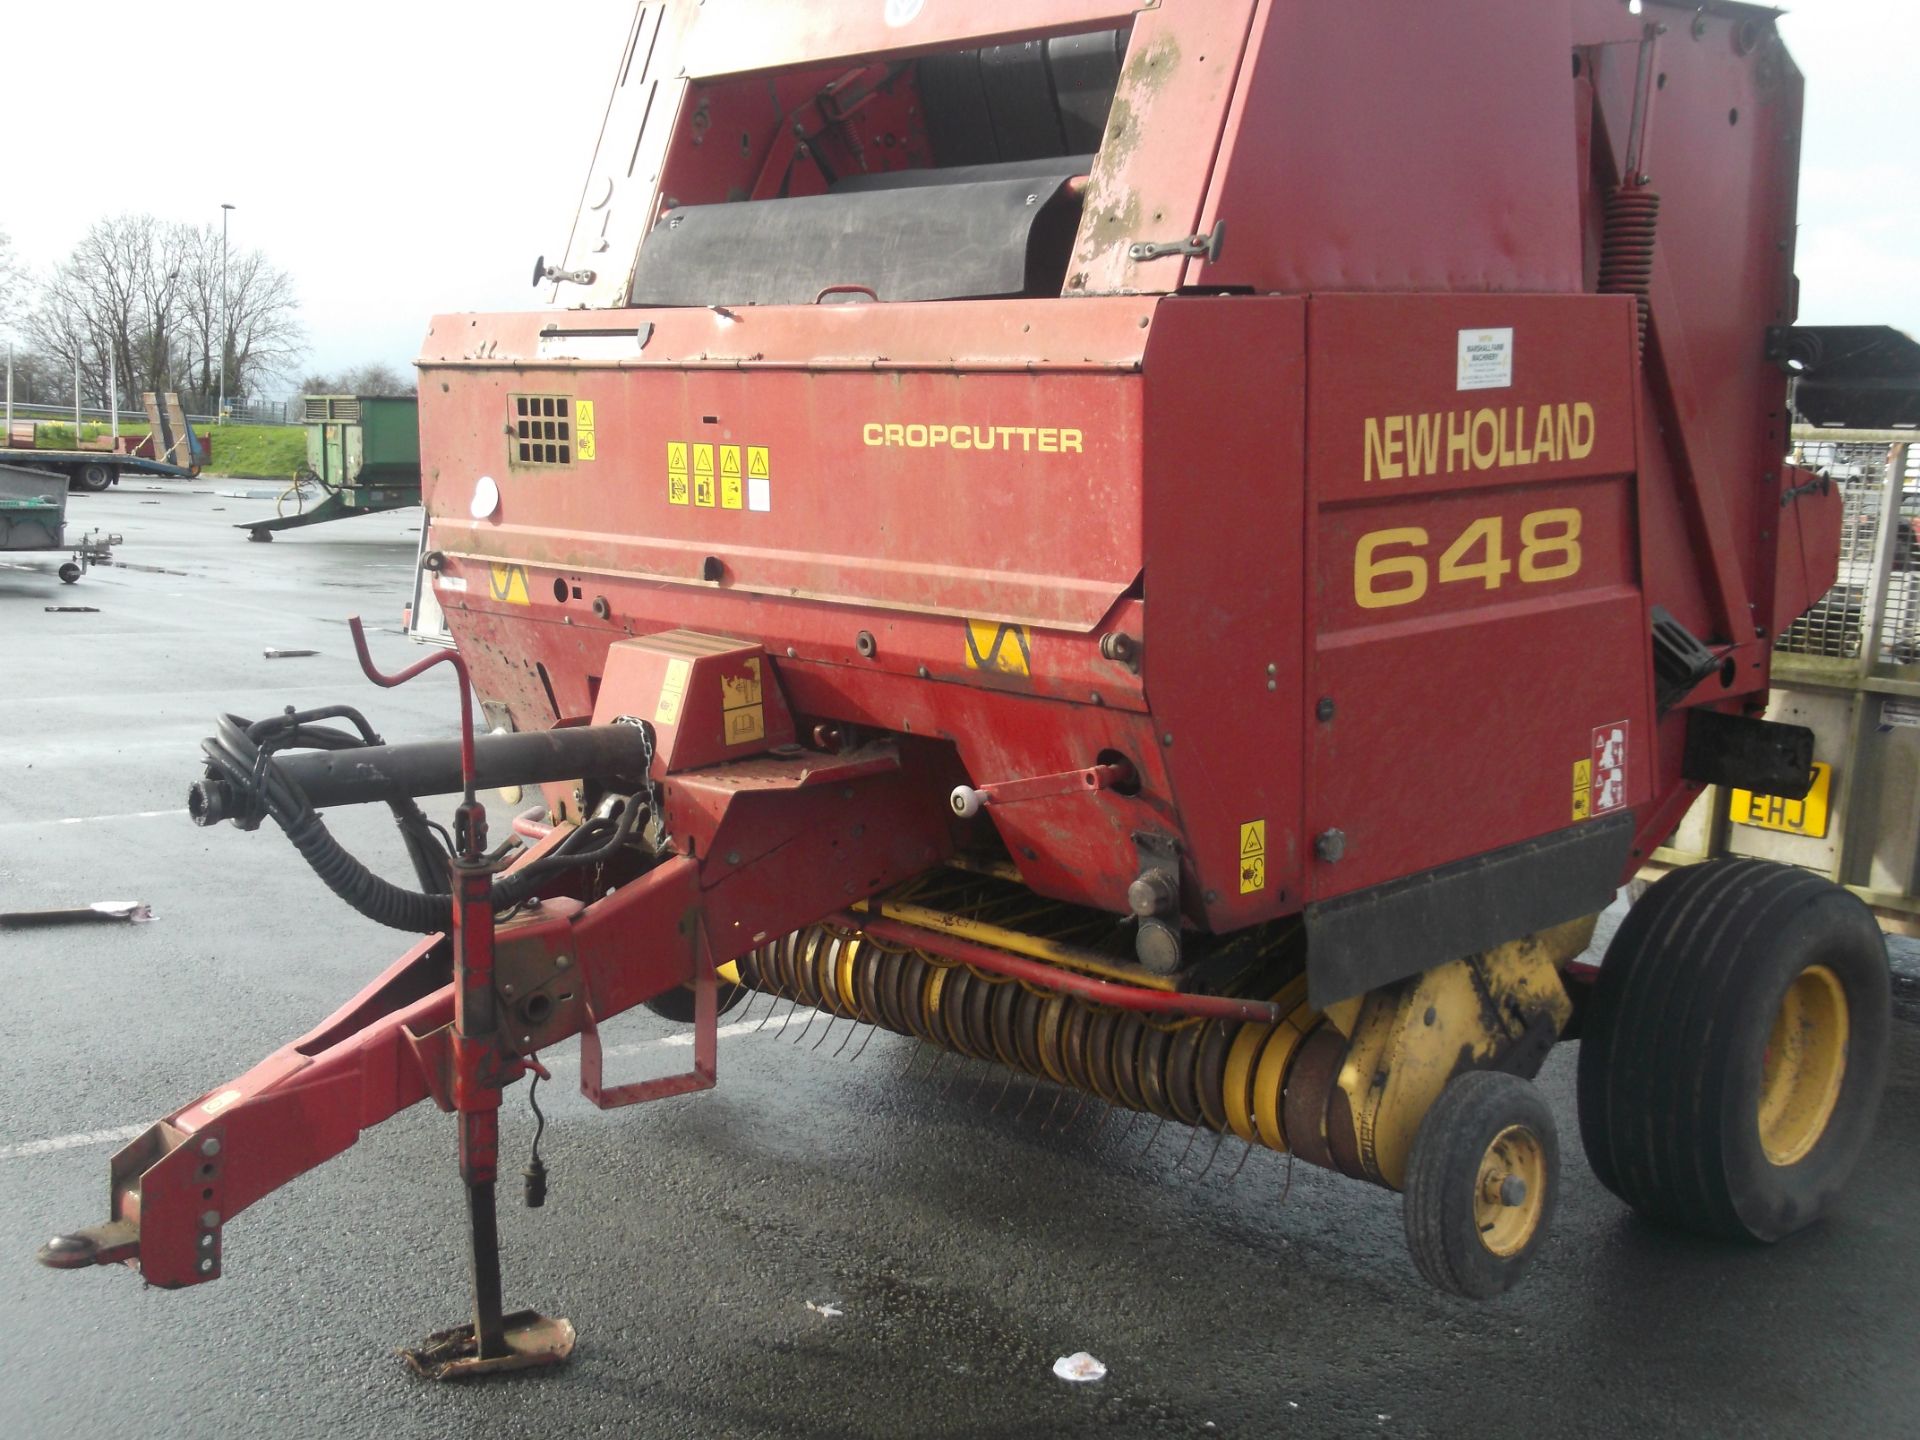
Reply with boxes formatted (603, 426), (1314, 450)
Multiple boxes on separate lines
(426, 367), (1140, 637)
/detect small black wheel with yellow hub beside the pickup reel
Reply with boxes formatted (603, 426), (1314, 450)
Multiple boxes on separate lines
(1405, 1069), (1559, 1300)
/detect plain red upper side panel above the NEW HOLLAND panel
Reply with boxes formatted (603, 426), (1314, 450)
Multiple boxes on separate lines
(1188, 0), (1582, 294)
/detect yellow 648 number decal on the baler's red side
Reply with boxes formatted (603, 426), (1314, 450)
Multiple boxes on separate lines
(1354, 509), (1582, 611)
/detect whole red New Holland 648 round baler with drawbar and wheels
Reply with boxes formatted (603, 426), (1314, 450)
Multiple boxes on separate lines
(42, 0), (1887, 1373)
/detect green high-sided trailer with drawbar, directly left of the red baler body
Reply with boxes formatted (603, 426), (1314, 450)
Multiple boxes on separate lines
(234, 396), (420, 540)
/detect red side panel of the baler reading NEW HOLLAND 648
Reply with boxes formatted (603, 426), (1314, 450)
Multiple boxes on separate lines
(1302, 296), (1653, 900)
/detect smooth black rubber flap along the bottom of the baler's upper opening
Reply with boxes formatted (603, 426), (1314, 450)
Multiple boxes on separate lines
(630, 167), (1085, 305)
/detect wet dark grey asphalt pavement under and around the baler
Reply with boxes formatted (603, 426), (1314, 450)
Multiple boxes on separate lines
(0, 484), (1920, 1440)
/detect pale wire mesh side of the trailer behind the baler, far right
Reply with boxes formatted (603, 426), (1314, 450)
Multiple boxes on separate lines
(1774, 430), (1920, 666)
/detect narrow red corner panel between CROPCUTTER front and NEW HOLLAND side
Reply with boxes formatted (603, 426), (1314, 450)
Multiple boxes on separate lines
(1142, 298), (1308, 931)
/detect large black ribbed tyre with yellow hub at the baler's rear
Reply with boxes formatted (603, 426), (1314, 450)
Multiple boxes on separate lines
(1578, 860), (1893, 1242)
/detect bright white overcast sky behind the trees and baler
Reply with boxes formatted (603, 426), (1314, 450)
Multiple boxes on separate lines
(0, 0), (1920, 391)
